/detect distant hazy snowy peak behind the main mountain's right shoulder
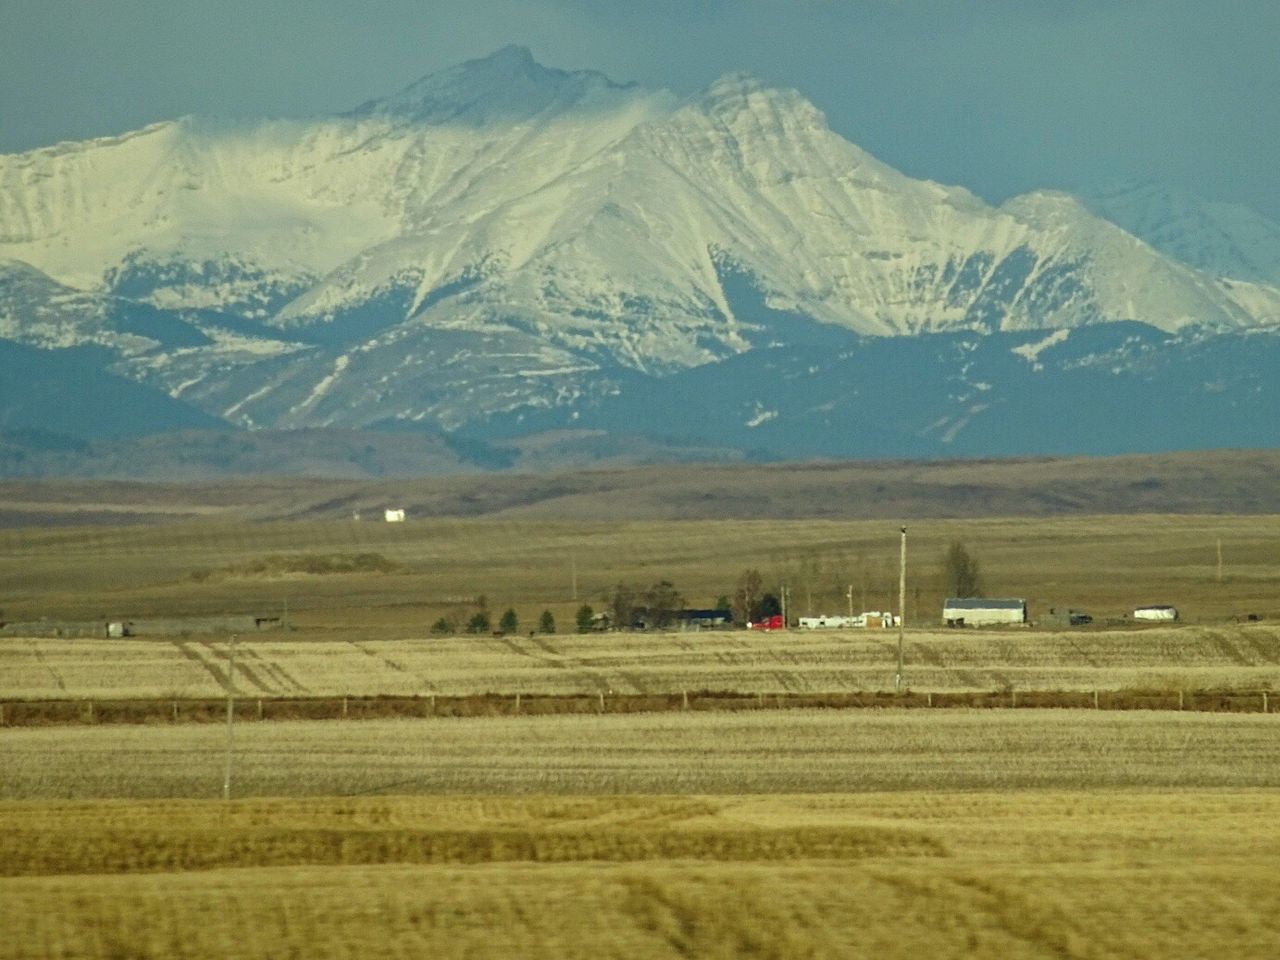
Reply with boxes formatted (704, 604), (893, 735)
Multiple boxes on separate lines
(1083, 182), (1280, 287)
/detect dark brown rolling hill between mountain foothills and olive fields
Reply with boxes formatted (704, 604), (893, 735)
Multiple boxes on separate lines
(0, 449), (1280, 527)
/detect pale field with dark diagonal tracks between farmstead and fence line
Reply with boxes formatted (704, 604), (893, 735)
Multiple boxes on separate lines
(0, 623), (1280, 701)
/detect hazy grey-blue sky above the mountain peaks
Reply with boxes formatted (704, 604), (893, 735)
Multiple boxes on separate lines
(0, 0), (1280, 218)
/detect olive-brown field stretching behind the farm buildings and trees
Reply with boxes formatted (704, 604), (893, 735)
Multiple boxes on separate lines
(0, 515), (1280, 640)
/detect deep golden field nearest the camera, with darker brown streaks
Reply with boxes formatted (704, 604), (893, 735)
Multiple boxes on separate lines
(0, 788), (1280, 960)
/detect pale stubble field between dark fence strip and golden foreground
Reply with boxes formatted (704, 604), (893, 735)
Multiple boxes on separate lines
(0, 709), (1280, 800)
